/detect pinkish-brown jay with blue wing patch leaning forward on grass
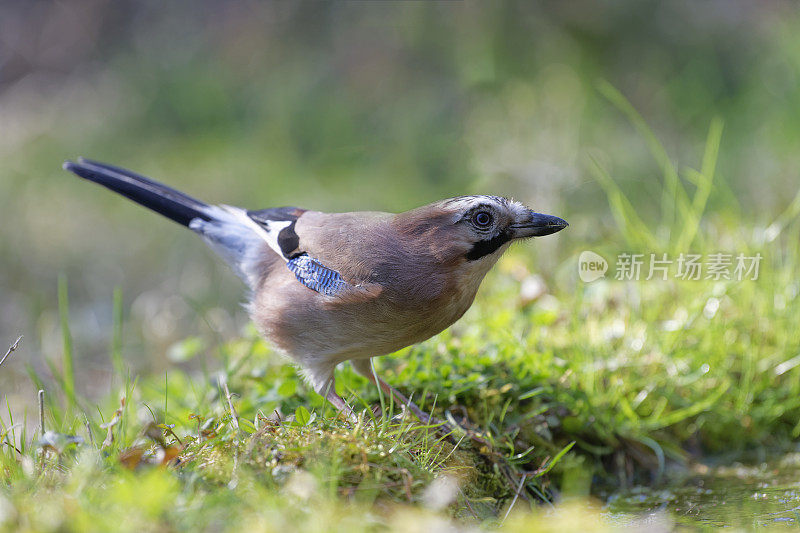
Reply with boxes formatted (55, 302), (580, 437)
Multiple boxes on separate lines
(63, 158), (568, 423)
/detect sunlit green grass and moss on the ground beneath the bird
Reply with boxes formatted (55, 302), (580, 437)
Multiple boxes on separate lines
(0, 91), (800, 531)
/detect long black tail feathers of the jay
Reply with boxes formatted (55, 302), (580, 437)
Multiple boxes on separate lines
(64, 158), (212, 226)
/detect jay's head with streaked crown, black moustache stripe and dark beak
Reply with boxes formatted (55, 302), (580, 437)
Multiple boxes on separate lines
(402, 195), (568, 270)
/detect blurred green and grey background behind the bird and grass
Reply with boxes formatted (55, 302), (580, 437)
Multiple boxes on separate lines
(0, 0), (800, 405)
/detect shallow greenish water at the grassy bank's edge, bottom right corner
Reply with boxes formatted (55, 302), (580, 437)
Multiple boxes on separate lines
(605, 453), (800, 530)
